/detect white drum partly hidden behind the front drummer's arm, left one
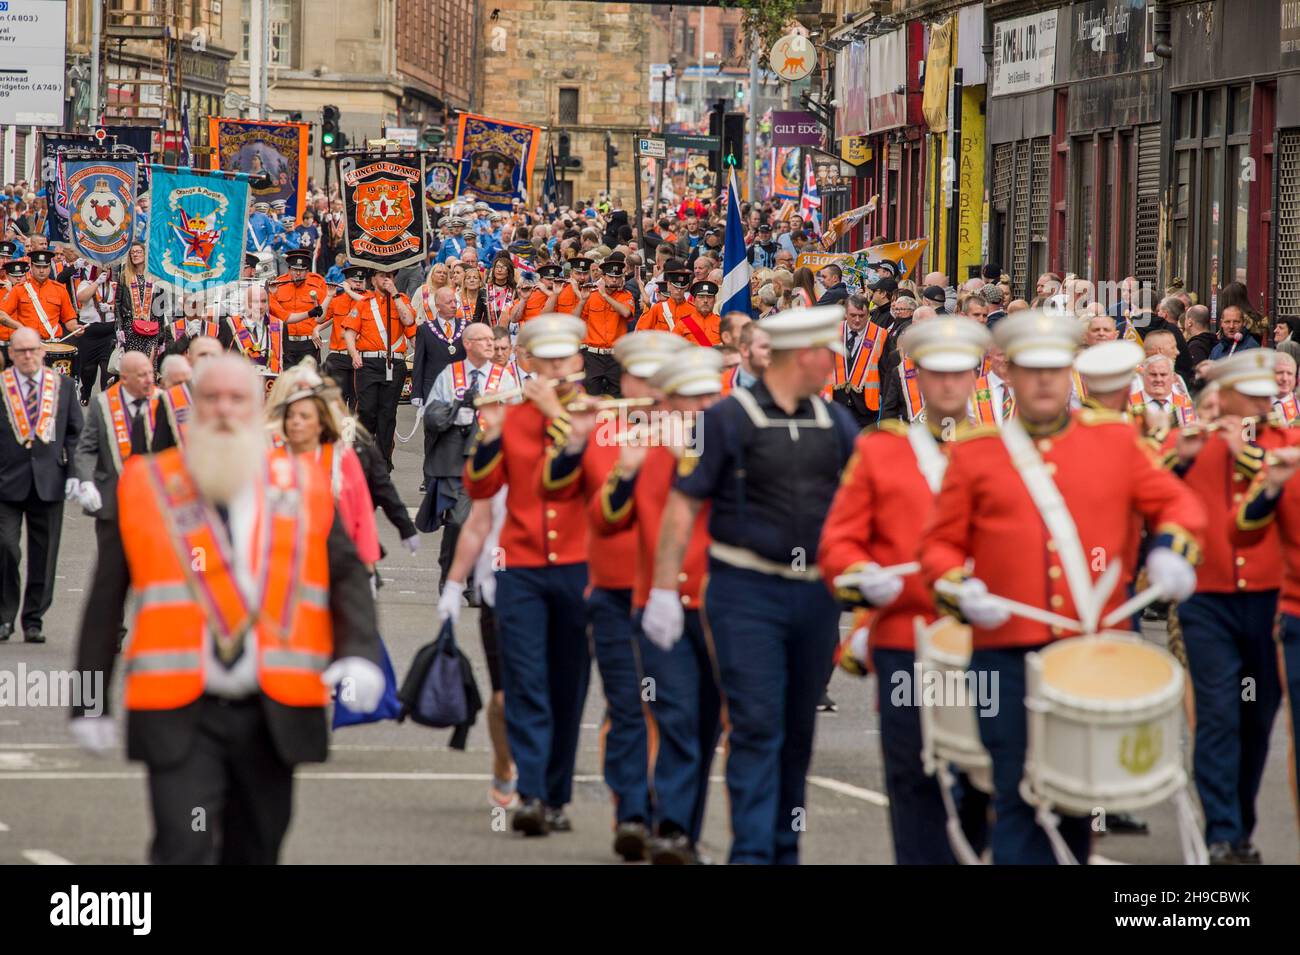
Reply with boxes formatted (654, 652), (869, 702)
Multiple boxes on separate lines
(915, 617), (993, 793)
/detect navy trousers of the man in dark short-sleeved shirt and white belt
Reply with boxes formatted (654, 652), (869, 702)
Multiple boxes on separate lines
(703, 560), (840, 865)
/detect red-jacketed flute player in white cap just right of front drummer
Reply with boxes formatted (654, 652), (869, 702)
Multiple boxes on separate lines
(1165, 348), (1295, 864)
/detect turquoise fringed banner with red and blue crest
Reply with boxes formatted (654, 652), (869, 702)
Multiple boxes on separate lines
(148, 166), (248, 292)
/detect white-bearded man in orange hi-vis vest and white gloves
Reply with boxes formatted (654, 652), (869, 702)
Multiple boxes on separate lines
(73, 353), (384, 864)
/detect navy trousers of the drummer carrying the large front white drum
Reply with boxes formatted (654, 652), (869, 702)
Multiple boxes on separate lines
(971, 647), (1092, 865)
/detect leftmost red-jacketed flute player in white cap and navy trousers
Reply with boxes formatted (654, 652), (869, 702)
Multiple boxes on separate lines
(465, 314), (594, 835)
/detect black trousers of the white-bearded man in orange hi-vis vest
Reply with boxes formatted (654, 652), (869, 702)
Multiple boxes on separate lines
(150, 696), (294, 865)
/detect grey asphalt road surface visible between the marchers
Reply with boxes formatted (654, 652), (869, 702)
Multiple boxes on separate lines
(0, 407), (1300, 864)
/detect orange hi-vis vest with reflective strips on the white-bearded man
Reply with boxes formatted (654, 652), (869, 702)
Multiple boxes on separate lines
(117, 448), (334, 709)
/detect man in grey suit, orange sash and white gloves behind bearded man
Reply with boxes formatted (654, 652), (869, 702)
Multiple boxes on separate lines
(73, 352), (153, 657)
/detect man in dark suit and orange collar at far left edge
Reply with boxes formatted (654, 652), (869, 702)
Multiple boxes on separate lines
(0, 328), (82, 643)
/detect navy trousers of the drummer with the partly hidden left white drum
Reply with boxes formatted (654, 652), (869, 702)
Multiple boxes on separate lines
(871, 647), (988, 865)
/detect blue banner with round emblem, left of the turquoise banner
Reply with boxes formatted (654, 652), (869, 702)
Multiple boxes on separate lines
(62, 160), (137, 268)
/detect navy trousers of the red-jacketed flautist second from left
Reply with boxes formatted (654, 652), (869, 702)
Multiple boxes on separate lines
(586, 587), (650, 822)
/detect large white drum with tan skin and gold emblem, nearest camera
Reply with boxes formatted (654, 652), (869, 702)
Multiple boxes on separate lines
(1024, 633), (1187, 816)
